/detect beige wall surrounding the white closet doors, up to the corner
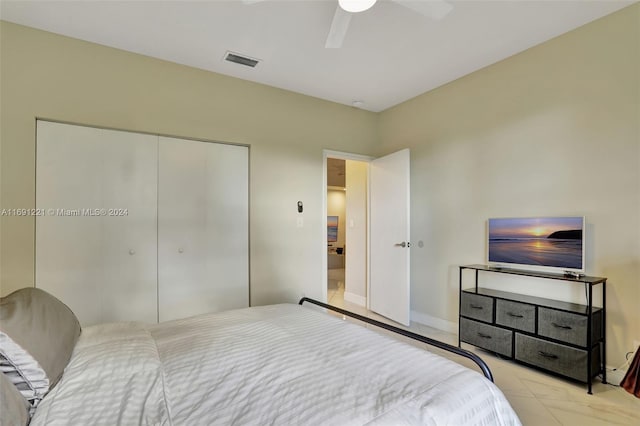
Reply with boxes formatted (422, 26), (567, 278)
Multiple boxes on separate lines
(0, 22), (377, 304)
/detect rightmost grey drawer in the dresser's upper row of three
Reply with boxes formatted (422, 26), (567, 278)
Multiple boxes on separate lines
(538, 307), (587, 346)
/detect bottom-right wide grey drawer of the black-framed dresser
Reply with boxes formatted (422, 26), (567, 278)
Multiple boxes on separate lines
(515, 333), (600, 382)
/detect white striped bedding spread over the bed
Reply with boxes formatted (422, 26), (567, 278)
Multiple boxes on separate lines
(31, 305), (520, 426)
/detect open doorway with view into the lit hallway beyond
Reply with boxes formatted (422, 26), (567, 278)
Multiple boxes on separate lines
(323, 152), (370, 309)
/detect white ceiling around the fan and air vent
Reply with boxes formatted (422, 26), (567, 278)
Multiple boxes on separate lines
(0, 0), (635, 111)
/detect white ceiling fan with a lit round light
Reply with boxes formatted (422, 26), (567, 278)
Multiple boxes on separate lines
(242, 0), (453, 49)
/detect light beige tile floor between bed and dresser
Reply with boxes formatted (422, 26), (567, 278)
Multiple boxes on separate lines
(327, 269), (640, 426)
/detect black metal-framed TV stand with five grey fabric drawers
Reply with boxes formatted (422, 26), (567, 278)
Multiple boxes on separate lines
(458, 265), (607, 394)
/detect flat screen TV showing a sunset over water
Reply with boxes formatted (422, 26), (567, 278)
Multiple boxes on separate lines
(487, 216), (585, 274)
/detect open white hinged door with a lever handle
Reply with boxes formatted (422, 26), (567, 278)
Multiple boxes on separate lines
(369, 149), (411, 325)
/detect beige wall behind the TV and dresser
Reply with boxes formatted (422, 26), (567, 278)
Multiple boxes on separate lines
(377, 5), (640, 365)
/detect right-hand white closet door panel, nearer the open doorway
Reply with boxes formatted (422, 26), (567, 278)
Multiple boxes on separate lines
(158, 137), (249, 321)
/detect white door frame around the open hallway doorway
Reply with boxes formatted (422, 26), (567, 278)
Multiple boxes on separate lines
(320, 149), (375, 309)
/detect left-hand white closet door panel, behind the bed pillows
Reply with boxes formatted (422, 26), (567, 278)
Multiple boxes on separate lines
(36, 121), (158, 326)
